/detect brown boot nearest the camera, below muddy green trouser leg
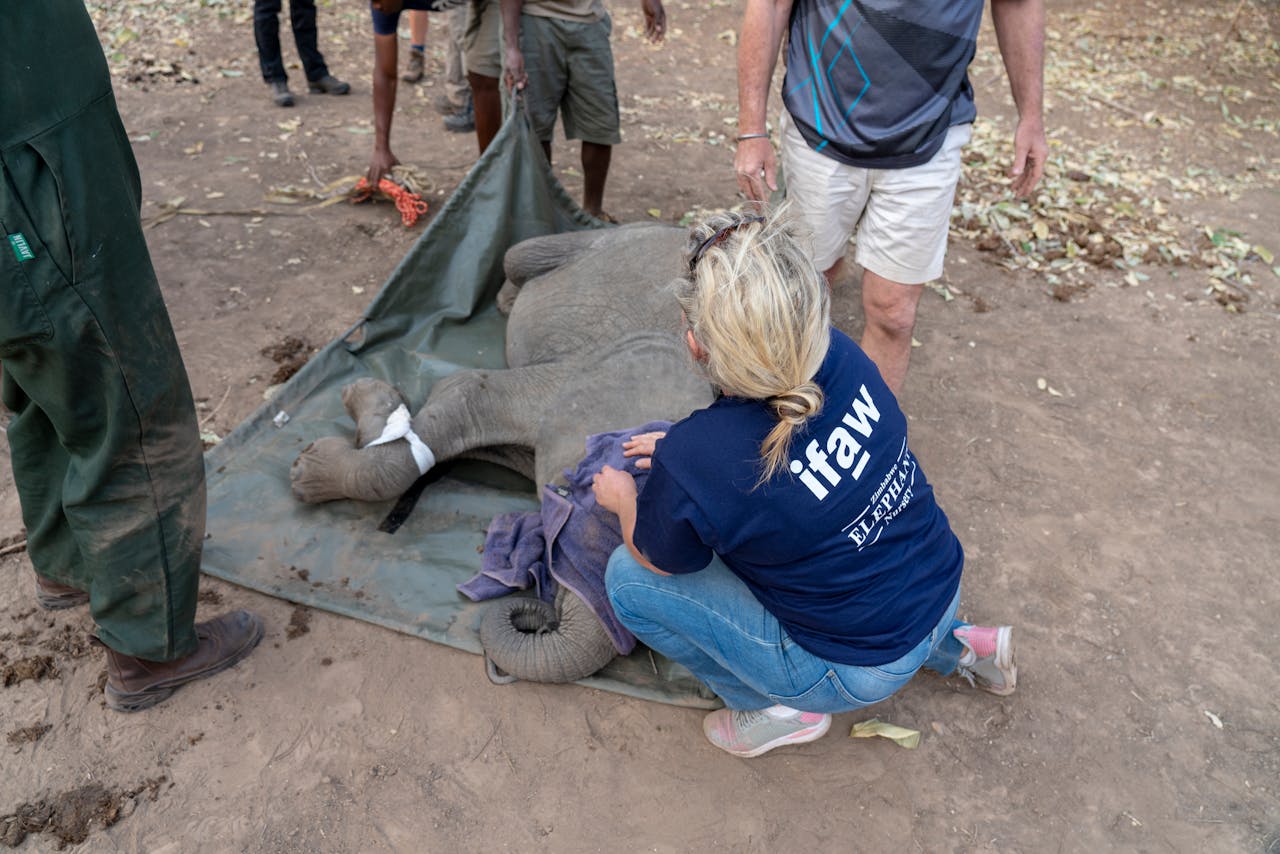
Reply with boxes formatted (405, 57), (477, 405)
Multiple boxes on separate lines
(102, 611), (262, 712)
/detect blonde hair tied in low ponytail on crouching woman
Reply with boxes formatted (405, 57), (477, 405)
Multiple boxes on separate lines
(676, 209), (831, 485)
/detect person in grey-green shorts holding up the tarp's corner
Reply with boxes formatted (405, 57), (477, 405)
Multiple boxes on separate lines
(502, 0), (667, 220)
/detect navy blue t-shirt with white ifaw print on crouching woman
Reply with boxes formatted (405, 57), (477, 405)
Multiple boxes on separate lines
(635, 329), (964, 666)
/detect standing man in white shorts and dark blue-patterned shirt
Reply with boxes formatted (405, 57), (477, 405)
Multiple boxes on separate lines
(733, 0), (1048, 394)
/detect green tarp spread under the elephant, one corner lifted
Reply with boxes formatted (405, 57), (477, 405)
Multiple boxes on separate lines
(204, 104), (719, 708)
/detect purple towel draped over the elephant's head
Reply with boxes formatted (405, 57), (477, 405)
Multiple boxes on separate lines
(458, 421), (671, 656)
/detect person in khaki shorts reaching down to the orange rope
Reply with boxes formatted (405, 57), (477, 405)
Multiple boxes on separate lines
(366, 0), (502, 187)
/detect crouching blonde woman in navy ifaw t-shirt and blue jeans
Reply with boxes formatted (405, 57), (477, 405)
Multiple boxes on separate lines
(594, 214), (1018, 757)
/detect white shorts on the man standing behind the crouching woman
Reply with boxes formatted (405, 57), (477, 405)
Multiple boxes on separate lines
(781, 110), (973, 284)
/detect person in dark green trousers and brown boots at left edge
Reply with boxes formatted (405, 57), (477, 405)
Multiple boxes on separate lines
(0, 0), (262, 712)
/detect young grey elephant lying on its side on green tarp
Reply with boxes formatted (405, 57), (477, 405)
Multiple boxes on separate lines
(291, 225), (713, 681)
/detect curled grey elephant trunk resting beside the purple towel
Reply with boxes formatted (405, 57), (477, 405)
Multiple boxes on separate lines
(480, 586), (617, 682)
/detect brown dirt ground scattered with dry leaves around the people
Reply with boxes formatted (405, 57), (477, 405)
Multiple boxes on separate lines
(0, 0), (1280, 853)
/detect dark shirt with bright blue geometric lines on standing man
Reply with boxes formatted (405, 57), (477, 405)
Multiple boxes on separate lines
(782, 0), (983, 169)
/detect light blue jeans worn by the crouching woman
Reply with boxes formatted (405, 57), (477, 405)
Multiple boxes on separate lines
(604, 545), (969, 713)
